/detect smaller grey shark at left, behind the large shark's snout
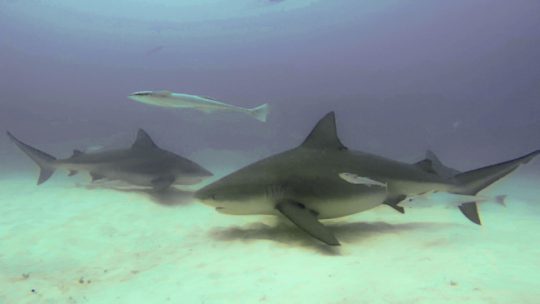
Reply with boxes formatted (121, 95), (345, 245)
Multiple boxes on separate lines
(7, 129), (212, 190)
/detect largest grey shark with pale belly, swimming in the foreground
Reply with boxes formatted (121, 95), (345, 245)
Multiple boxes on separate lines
(195, 112), (540, 245)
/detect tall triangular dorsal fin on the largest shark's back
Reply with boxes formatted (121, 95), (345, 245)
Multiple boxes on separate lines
(301, 112), (347, 150)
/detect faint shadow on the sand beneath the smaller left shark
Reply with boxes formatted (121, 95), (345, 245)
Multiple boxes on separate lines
(77, 183), (194, 207)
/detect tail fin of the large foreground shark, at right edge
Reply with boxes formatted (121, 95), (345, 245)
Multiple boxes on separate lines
(451, 150), (540, 225)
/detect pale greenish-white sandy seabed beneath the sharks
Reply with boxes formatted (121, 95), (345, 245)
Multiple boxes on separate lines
(0, 170), (540, 304)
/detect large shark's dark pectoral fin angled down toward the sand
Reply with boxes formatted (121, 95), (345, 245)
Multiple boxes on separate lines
(276, 200), (340, 246)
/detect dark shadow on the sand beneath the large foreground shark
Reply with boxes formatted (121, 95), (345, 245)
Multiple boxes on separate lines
(210, 219), (454, 255)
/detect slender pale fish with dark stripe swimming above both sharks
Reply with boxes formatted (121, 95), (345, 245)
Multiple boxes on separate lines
(128, 90), (268, 122)
